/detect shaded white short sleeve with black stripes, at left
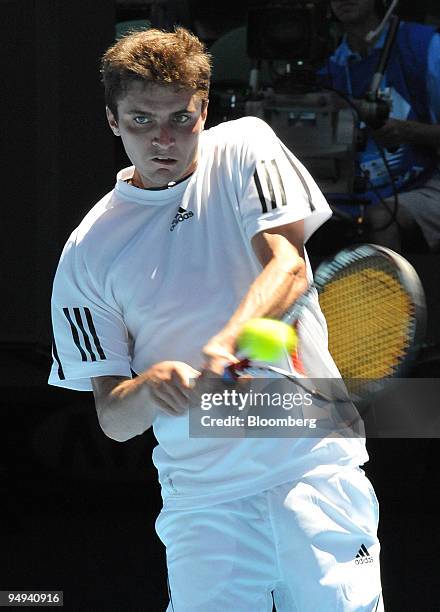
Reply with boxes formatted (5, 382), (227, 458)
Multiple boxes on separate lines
(49, 238), (131, 391)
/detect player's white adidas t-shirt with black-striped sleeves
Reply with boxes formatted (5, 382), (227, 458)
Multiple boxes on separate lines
(49, 117), (368, 508)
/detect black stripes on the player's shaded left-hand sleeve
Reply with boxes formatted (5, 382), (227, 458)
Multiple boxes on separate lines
(53, 307), (107, 380)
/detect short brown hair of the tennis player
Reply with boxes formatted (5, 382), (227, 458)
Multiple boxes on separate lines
(101, 27), (211, 118)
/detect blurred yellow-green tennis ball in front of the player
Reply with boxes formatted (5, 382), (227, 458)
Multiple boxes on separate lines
(237, 318), (297, 362)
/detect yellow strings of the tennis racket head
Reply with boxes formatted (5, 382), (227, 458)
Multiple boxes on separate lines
(319, 258), (414, 379)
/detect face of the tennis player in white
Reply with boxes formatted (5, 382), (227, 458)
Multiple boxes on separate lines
(107, 82), (207, 188)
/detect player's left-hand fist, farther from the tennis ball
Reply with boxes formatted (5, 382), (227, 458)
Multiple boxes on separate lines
(142, 361), (200, 416)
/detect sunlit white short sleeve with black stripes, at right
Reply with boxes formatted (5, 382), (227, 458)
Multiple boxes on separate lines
(240, 117), (331, 242)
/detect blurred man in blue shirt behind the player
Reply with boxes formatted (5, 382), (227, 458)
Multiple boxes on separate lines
(324, 0), (440, 251)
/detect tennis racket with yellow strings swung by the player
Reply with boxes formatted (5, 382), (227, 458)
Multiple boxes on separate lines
(228, 244), (426, 401)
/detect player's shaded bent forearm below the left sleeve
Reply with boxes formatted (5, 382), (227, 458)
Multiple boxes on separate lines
(94, 376), (157, 442)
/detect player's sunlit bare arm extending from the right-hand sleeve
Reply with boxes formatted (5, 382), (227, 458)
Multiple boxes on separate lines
(203, 220), (307, 374)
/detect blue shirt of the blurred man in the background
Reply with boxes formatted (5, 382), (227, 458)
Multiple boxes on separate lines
(320, 22), (440, 202)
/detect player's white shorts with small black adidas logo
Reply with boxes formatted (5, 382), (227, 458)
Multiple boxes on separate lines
(156, 468), (383, 612)
